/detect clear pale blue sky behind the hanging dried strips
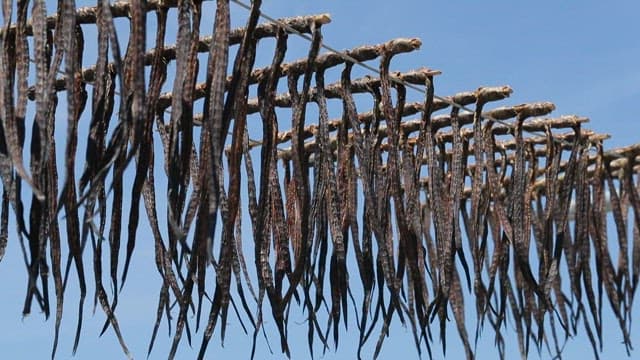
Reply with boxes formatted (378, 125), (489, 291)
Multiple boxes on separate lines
(0, 0), (640, 359)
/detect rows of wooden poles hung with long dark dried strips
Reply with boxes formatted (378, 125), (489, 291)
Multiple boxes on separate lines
(0, 0), (640, 358)
